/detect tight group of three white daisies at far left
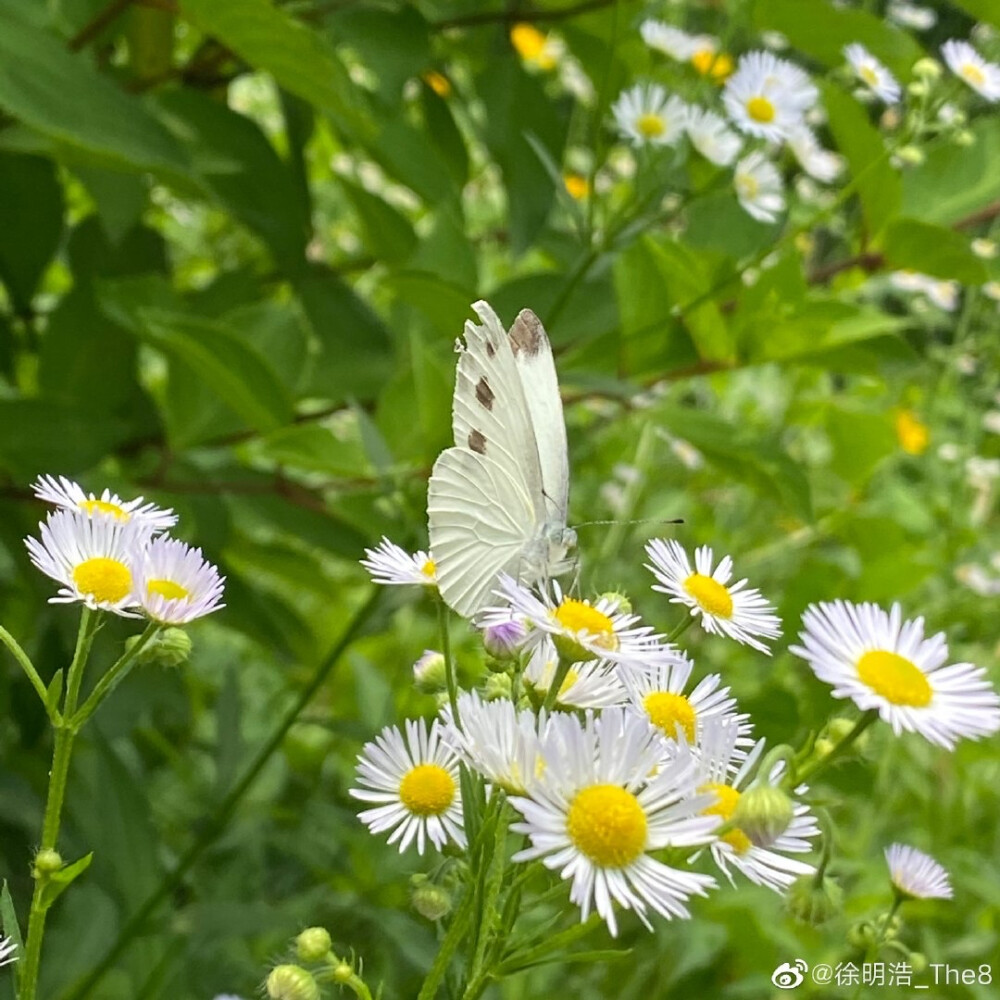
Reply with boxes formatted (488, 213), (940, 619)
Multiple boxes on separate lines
(25, 476), (225, 625)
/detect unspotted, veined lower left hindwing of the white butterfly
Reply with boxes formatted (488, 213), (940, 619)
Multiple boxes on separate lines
(427, 445), (538, 618)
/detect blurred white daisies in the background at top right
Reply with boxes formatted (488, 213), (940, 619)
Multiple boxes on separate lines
(612, 20), (1000, 223)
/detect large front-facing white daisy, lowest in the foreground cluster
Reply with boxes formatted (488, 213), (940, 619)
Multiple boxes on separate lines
(510, 708), (718, 935)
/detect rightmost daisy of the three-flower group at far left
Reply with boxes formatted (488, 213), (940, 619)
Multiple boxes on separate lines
(135, 536), (226, 625)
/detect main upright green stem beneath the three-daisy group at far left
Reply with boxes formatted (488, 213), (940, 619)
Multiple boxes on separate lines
(19, 607), (100, 1000)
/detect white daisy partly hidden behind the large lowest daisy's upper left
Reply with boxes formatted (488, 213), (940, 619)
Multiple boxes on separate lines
(441, 691), (545, 795)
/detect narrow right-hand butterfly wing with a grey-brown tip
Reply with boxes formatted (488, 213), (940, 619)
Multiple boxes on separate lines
(509, 309), (569, 527)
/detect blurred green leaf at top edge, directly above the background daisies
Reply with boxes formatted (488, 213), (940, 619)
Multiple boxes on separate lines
(753, 0), (924, 80)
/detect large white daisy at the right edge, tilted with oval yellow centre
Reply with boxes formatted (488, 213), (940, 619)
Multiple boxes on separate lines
(791, 601), (1000, 750)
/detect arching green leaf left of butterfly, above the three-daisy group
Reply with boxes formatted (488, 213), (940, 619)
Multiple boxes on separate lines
(137, 308), (292, 431)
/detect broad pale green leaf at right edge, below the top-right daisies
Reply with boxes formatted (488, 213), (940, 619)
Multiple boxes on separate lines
(903, 115), (1000, 226)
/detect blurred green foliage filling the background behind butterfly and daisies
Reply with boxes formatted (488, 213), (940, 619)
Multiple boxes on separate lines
(0, 0), (1000, 1000)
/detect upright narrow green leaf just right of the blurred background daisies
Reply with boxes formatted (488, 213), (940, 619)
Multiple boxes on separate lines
(820, 80), (903, 240)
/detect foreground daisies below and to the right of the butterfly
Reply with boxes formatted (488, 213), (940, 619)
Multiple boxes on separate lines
(352, 539), (1000, 933)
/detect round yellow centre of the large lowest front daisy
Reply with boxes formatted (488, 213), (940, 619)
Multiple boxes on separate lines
(566, 785), (646, 868)
